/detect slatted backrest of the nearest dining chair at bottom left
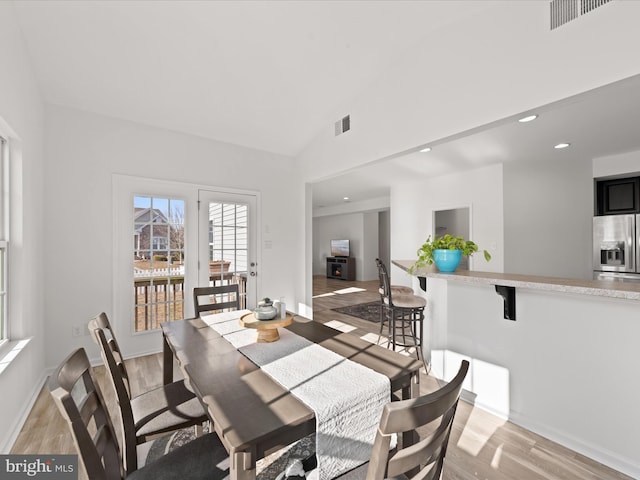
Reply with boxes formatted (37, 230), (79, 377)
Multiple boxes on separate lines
(48, 348), (123, 480)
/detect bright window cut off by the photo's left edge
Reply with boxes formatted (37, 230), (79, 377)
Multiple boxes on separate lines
(0, 137), (9, 345)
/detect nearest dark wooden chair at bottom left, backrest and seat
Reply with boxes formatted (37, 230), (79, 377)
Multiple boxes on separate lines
(48, 348), (229, 480)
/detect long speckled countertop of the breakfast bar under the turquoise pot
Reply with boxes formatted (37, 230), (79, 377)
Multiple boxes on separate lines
(391, 260), (640, 300)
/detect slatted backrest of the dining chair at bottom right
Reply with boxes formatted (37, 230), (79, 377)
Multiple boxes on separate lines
(366, 360), (469, 480)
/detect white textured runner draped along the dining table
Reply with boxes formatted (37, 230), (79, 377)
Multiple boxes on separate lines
(202, 310), (391, 480)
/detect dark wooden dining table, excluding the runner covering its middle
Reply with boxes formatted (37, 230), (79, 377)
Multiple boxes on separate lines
(161, 312), (422, 480)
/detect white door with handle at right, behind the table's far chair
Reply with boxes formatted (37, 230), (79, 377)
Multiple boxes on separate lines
(198, 190), (258, 309)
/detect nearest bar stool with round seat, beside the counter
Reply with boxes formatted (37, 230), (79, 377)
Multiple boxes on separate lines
(378, 262), (429, 373)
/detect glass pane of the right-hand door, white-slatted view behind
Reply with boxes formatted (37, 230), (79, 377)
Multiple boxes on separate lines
(209, 202), (248, 308)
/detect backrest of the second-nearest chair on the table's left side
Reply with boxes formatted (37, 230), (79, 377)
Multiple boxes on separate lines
(89, 313), (138, 472)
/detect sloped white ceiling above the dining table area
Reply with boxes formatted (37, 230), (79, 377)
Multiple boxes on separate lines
(14, 0), (491, 156)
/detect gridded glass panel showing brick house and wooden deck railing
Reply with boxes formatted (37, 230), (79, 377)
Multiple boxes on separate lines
(133, 196), (185, 332)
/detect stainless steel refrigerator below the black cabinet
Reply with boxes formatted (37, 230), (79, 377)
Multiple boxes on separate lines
(593, 214), (640, 282)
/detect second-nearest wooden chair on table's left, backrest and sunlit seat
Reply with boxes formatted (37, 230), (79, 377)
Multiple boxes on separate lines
(89, 312), (209, 445)
